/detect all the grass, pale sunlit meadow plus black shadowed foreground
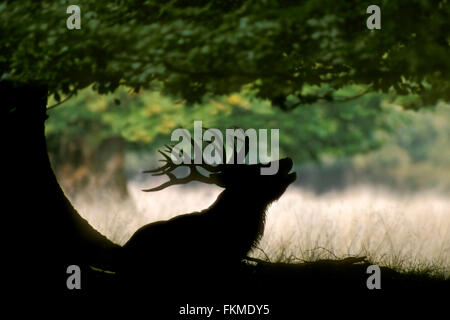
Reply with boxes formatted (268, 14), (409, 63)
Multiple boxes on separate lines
(71, 181), (450, 319)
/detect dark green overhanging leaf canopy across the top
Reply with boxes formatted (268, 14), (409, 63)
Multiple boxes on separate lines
(0, 0), (450, 109)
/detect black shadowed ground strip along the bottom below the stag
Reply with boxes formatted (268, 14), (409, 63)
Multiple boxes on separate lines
(88, 251), (450, 319)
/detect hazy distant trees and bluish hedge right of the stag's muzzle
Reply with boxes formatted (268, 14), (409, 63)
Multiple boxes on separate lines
(298, 103), (450, 194)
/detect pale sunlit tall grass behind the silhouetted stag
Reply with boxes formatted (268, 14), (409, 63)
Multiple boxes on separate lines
(72, 181), (450, 275)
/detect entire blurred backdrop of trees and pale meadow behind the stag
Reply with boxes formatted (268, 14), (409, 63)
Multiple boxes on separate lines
(46, 86), (450, 274)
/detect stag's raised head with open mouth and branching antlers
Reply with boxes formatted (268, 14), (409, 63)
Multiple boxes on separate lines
(143, 129), (296, 202)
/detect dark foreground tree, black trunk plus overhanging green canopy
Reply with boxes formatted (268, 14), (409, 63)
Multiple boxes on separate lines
(0, 0), (450, 292)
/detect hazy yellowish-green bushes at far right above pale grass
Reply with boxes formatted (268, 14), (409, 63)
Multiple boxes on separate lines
(353, 104), (450, 192)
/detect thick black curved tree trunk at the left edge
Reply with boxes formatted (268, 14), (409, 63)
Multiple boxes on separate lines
(0, 81), (120, 293)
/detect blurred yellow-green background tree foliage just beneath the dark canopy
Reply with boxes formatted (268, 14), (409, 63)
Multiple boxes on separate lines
(46, 88), (390, 162)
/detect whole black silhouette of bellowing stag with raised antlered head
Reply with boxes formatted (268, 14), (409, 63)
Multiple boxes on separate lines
(118, 129), (296, 290)
